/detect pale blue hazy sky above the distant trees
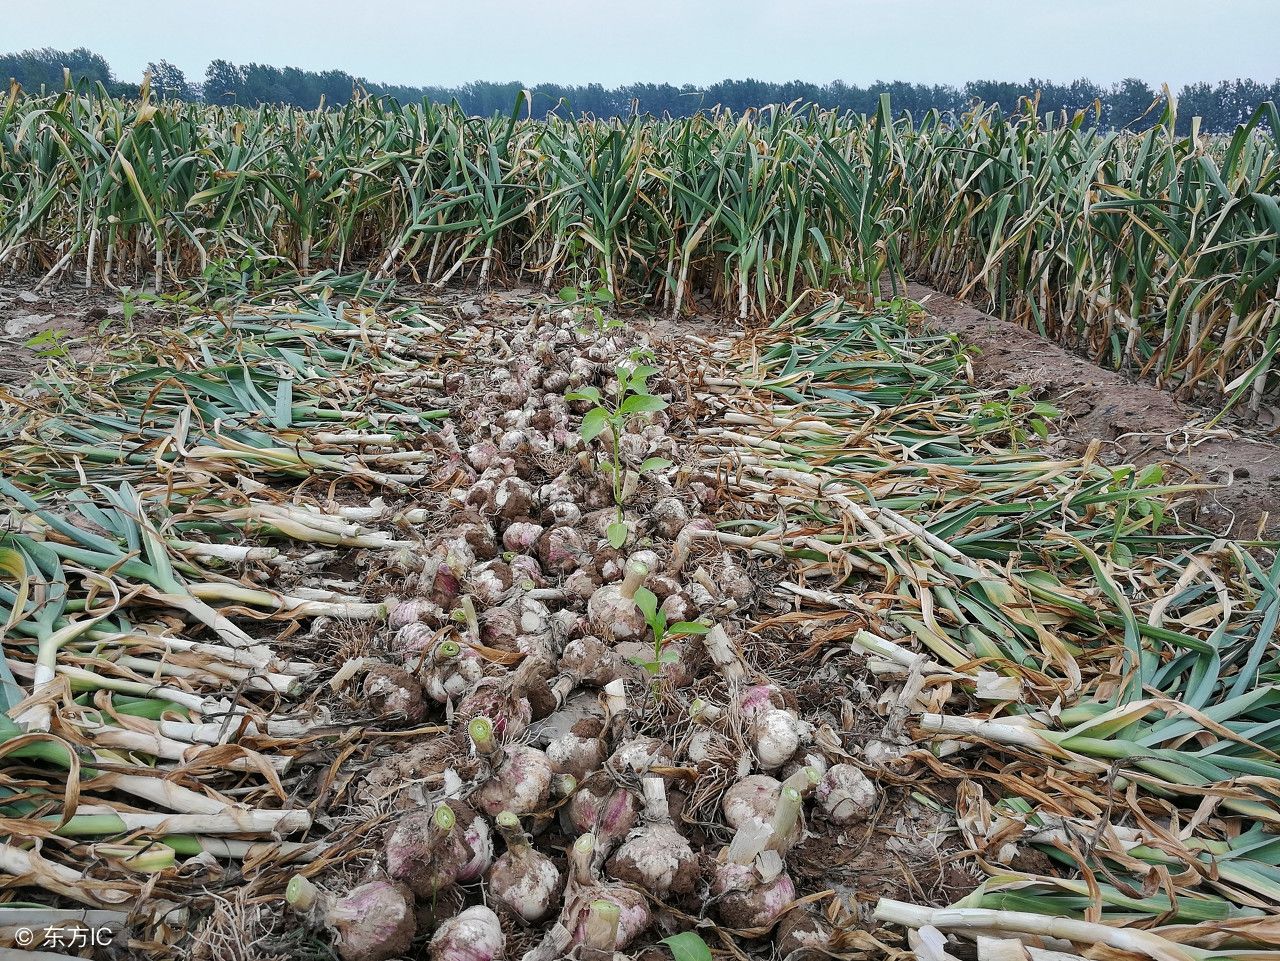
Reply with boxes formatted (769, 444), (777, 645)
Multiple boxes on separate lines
(0, 0), (1280, 87)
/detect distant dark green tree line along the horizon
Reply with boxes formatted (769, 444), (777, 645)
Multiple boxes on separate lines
(0, 47), (1280, 132)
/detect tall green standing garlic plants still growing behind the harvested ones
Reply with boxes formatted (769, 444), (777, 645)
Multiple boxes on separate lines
(0, 88), (1280, 406)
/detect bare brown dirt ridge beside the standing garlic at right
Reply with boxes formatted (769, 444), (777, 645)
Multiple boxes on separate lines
(908, 283), (1280, 537)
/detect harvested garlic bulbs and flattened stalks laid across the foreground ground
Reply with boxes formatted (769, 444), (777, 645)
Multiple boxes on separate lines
(0, 284), (1280, 961)
